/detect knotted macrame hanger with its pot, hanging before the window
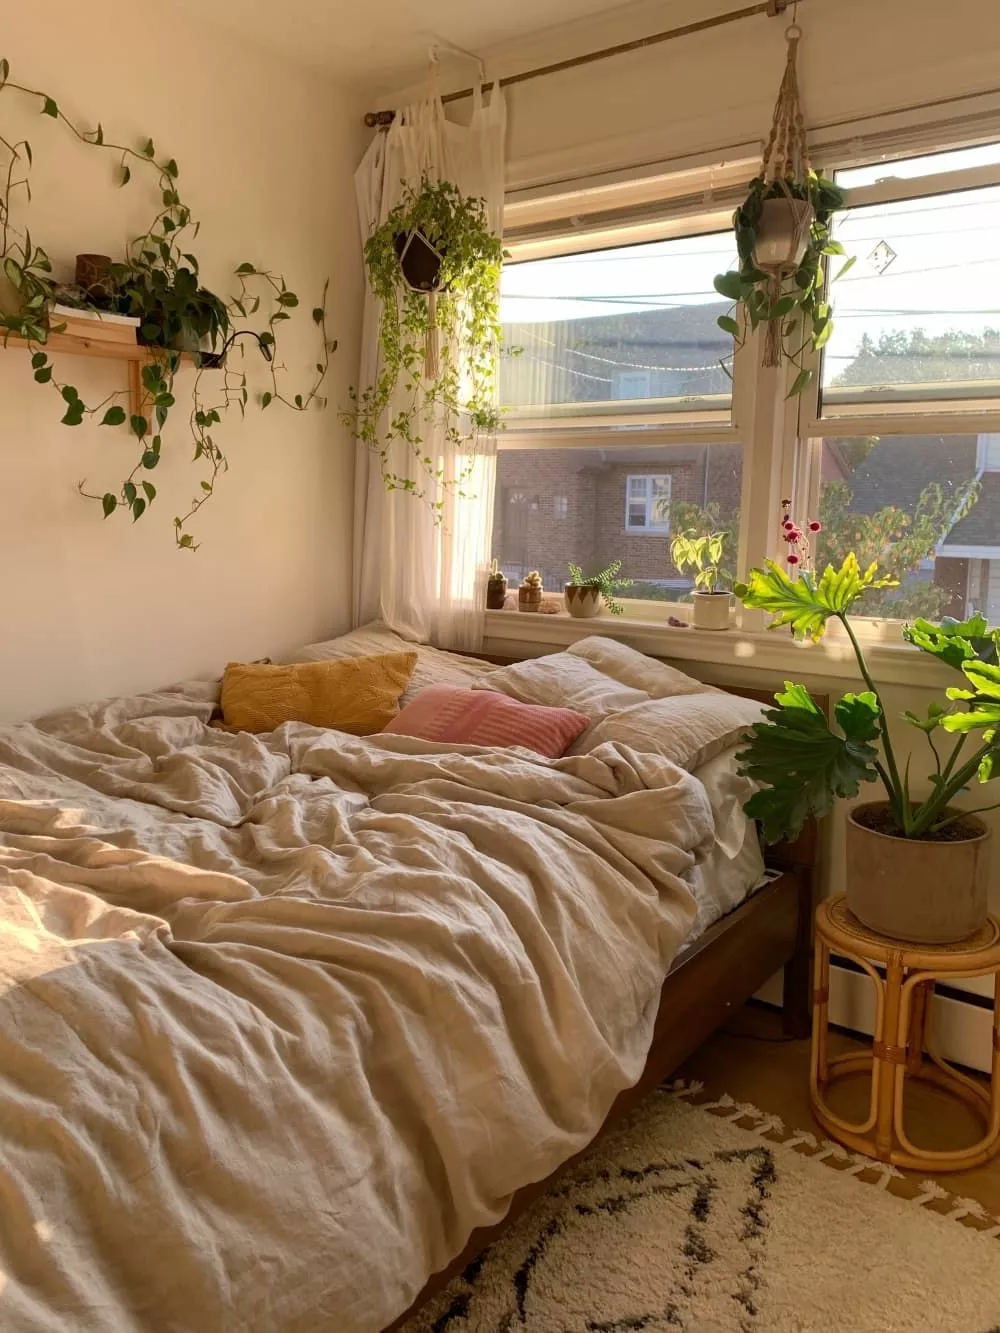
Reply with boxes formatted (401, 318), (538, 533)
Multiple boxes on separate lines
(753, 14), (815, 367)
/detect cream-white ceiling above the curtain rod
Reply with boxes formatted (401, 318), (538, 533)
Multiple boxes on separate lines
(173, 0), (626, 88)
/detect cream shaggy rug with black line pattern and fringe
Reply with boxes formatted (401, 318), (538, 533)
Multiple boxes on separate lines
(405, 1084), (1000, 1333)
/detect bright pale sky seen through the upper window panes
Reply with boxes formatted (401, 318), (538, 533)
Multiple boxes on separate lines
(501, 144), (1000, 397)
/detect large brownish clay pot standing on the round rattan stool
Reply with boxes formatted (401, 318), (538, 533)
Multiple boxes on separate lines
(847, 801), (991, 944)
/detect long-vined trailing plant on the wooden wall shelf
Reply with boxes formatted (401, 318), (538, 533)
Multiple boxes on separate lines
(0, 59), (336, 551)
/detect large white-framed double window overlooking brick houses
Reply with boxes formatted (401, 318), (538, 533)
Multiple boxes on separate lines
(493, 140), (1000, 633)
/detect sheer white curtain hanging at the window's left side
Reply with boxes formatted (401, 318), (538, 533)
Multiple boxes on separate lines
(353, 88), (507, 651)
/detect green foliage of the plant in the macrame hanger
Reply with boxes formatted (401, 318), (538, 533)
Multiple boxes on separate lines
(715, 171), (855, 397)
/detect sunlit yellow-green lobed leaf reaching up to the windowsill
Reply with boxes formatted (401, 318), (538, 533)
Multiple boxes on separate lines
(733, 552), (896, 641)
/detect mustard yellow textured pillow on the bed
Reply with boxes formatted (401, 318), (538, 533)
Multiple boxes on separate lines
(221, 653), (417, 736)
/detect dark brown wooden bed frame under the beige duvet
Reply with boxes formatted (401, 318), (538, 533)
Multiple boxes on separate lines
(384, 682), (828, 1333)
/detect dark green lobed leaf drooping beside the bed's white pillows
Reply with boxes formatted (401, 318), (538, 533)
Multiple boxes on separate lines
(737, 681), (880, 842)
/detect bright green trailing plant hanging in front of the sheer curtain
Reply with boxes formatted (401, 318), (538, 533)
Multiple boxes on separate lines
(344, 177), (504, 516)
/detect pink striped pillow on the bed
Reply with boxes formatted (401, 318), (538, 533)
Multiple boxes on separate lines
(383, 685), (589, 758)
